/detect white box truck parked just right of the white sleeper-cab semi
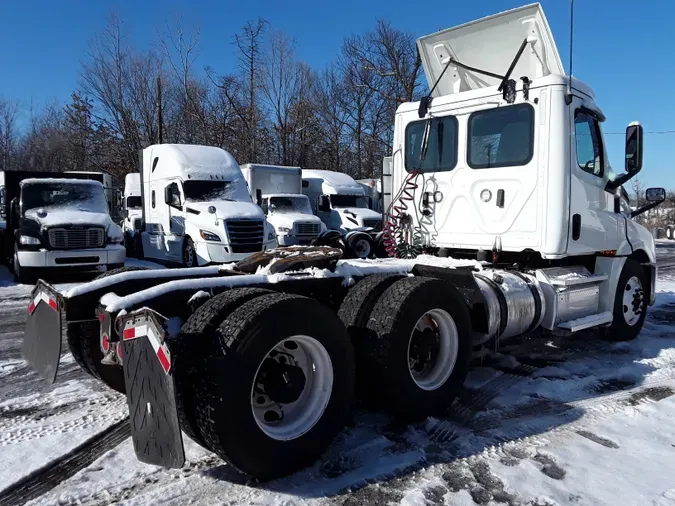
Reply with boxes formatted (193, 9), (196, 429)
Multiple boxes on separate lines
(241, 163), (326, 246)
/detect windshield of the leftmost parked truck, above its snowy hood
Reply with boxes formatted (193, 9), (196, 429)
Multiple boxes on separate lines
(22, 183), (108, 213)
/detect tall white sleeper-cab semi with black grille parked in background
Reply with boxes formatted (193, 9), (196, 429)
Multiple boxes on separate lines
(140, 144), (277, 267)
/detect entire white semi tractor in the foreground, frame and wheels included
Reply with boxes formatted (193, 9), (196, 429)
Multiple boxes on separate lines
(24, 4), (665, 486)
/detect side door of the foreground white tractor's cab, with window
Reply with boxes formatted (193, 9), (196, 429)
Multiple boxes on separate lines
(567, 97), (623, 255)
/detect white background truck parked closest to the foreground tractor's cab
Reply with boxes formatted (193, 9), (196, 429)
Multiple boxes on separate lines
(302, 169), (382, 231)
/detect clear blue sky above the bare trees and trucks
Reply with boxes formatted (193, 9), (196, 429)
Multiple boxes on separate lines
(0, 0), (675, 188)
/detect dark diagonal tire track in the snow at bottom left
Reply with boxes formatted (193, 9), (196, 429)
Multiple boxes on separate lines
(0, 417), (131, 506)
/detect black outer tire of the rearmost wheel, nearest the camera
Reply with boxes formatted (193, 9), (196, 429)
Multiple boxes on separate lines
(195, 293), (354, 480)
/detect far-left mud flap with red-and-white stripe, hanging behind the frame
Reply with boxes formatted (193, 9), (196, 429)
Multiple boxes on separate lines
(22, 280), (64, 384)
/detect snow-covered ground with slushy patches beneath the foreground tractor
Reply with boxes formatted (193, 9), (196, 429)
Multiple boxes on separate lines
(0, 255), (675, 506)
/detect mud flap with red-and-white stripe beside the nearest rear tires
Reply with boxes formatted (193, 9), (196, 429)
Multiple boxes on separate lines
(116, 308), (185, 467)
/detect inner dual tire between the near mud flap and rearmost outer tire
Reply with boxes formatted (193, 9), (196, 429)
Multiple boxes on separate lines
(173, 288), (274, 448)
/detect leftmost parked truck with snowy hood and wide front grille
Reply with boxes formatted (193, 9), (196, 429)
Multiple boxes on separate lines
(7, 178), (126, 282)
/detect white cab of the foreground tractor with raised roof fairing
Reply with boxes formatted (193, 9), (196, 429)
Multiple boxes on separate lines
(393, 4), (654, 262)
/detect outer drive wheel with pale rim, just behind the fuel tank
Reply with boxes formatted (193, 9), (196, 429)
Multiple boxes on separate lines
(354, 277), (471, 421)
